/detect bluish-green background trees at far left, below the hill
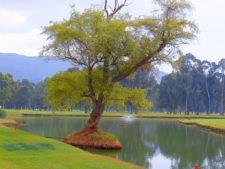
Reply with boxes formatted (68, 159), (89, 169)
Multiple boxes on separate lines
(0, 73), (45, 109)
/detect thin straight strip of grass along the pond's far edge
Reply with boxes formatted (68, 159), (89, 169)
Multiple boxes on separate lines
(5, 109), (225, 119)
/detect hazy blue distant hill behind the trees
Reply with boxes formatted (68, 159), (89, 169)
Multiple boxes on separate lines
(0, 53), (165, 83)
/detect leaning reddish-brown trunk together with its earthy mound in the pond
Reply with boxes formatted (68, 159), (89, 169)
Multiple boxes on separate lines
(63, 94), (122, 149)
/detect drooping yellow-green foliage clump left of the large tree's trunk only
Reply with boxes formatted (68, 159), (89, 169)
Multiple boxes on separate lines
(45, 72), (87, 109)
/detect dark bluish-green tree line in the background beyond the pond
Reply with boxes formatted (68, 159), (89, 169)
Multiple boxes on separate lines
(0, 54), (225, 114)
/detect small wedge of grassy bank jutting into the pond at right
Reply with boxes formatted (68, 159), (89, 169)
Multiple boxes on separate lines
(179, 119), (225, 134)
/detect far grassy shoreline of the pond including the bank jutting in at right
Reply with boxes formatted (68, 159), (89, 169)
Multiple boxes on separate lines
(3, 110), (225, 134)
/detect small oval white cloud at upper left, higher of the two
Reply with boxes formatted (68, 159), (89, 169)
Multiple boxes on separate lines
(0, 9), (27, 29)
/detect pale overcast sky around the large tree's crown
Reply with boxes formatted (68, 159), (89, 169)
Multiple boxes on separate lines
(0, 0), (225, 70)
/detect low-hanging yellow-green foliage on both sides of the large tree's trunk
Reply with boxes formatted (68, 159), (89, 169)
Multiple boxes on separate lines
(46, 71), (151, 111)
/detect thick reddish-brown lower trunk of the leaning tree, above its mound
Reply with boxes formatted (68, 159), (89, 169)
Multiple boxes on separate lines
(84, 96), (105, 134)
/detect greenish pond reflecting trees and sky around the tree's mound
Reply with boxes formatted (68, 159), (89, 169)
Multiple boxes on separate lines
(16, 117), (225, 169)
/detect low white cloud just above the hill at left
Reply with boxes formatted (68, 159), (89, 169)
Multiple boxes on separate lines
(0, 29), (45, 56)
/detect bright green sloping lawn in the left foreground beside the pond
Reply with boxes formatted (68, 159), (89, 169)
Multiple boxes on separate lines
(0, 127), (140, 169)
